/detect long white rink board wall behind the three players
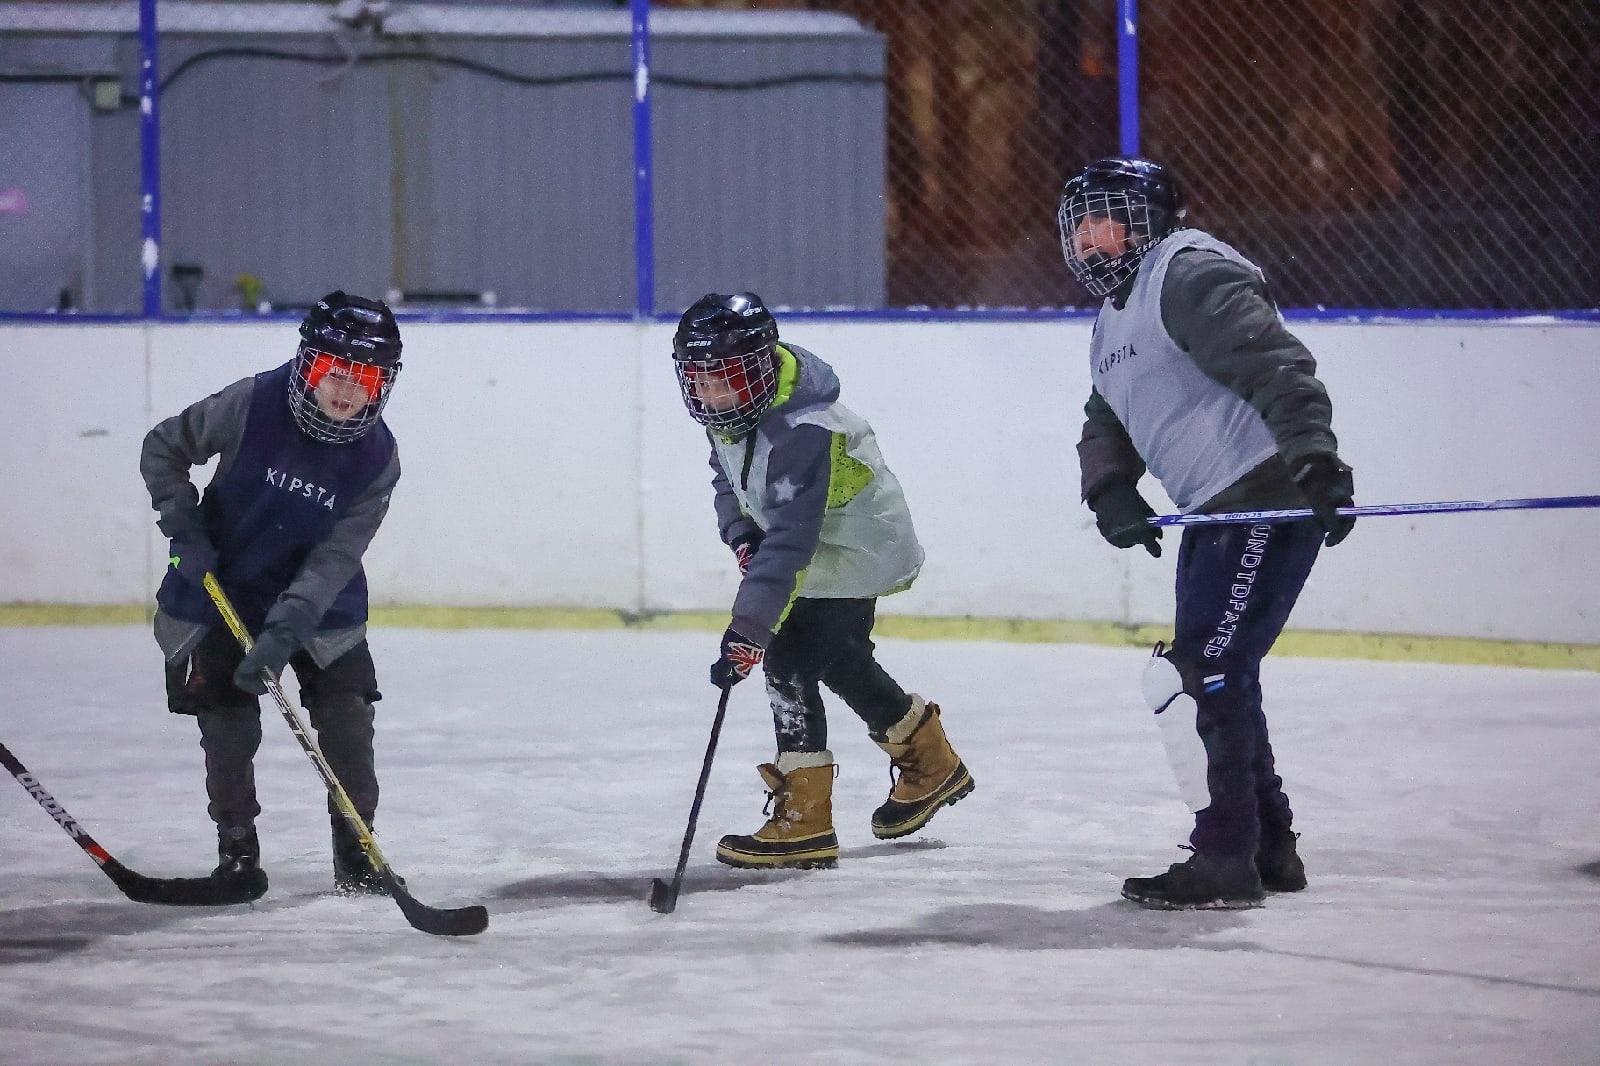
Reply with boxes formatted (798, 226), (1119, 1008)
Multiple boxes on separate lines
(0, 315), (1600, 643)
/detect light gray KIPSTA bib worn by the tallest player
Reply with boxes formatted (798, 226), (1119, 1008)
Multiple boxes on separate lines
(1090, 229), (1278, 514)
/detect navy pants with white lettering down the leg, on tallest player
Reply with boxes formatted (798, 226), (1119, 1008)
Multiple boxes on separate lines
(1170, 520), (1323, 856)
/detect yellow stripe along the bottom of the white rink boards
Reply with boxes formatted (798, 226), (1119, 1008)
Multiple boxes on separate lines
(0, 603), (1600, 672)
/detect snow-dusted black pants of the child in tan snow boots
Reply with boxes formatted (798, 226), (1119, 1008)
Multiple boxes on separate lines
(763, 599), (910, 752)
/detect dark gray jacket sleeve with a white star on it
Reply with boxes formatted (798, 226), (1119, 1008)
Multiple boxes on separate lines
(733, 423), (834, 645)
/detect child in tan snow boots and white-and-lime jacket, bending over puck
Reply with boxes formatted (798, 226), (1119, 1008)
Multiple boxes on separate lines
(672, 293), (973, 868)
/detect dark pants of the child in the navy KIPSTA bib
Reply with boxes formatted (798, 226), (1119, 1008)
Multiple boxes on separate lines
(166, 626), (382, 826)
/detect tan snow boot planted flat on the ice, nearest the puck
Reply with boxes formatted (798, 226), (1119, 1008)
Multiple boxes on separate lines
(717, 751), (838, 869)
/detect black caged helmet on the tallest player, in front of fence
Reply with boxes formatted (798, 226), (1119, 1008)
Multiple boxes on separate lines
(1056, 157), (1184, 296)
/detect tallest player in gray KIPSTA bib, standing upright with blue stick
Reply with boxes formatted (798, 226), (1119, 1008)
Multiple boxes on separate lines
(1058, 158), (1355, 909)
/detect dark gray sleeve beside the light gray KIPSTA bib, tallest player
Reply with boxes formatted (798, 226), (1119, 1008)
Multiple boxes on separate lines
(1162, 250), (1339, 467)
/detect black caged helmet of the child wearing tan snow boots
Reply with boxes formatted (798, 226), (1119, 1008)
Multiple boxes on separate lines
(672, 293), (778, 439)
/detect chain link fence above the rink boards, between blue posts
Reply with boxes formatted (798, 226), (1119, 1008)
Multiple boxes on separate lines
(0, 0), (1600, 312)
